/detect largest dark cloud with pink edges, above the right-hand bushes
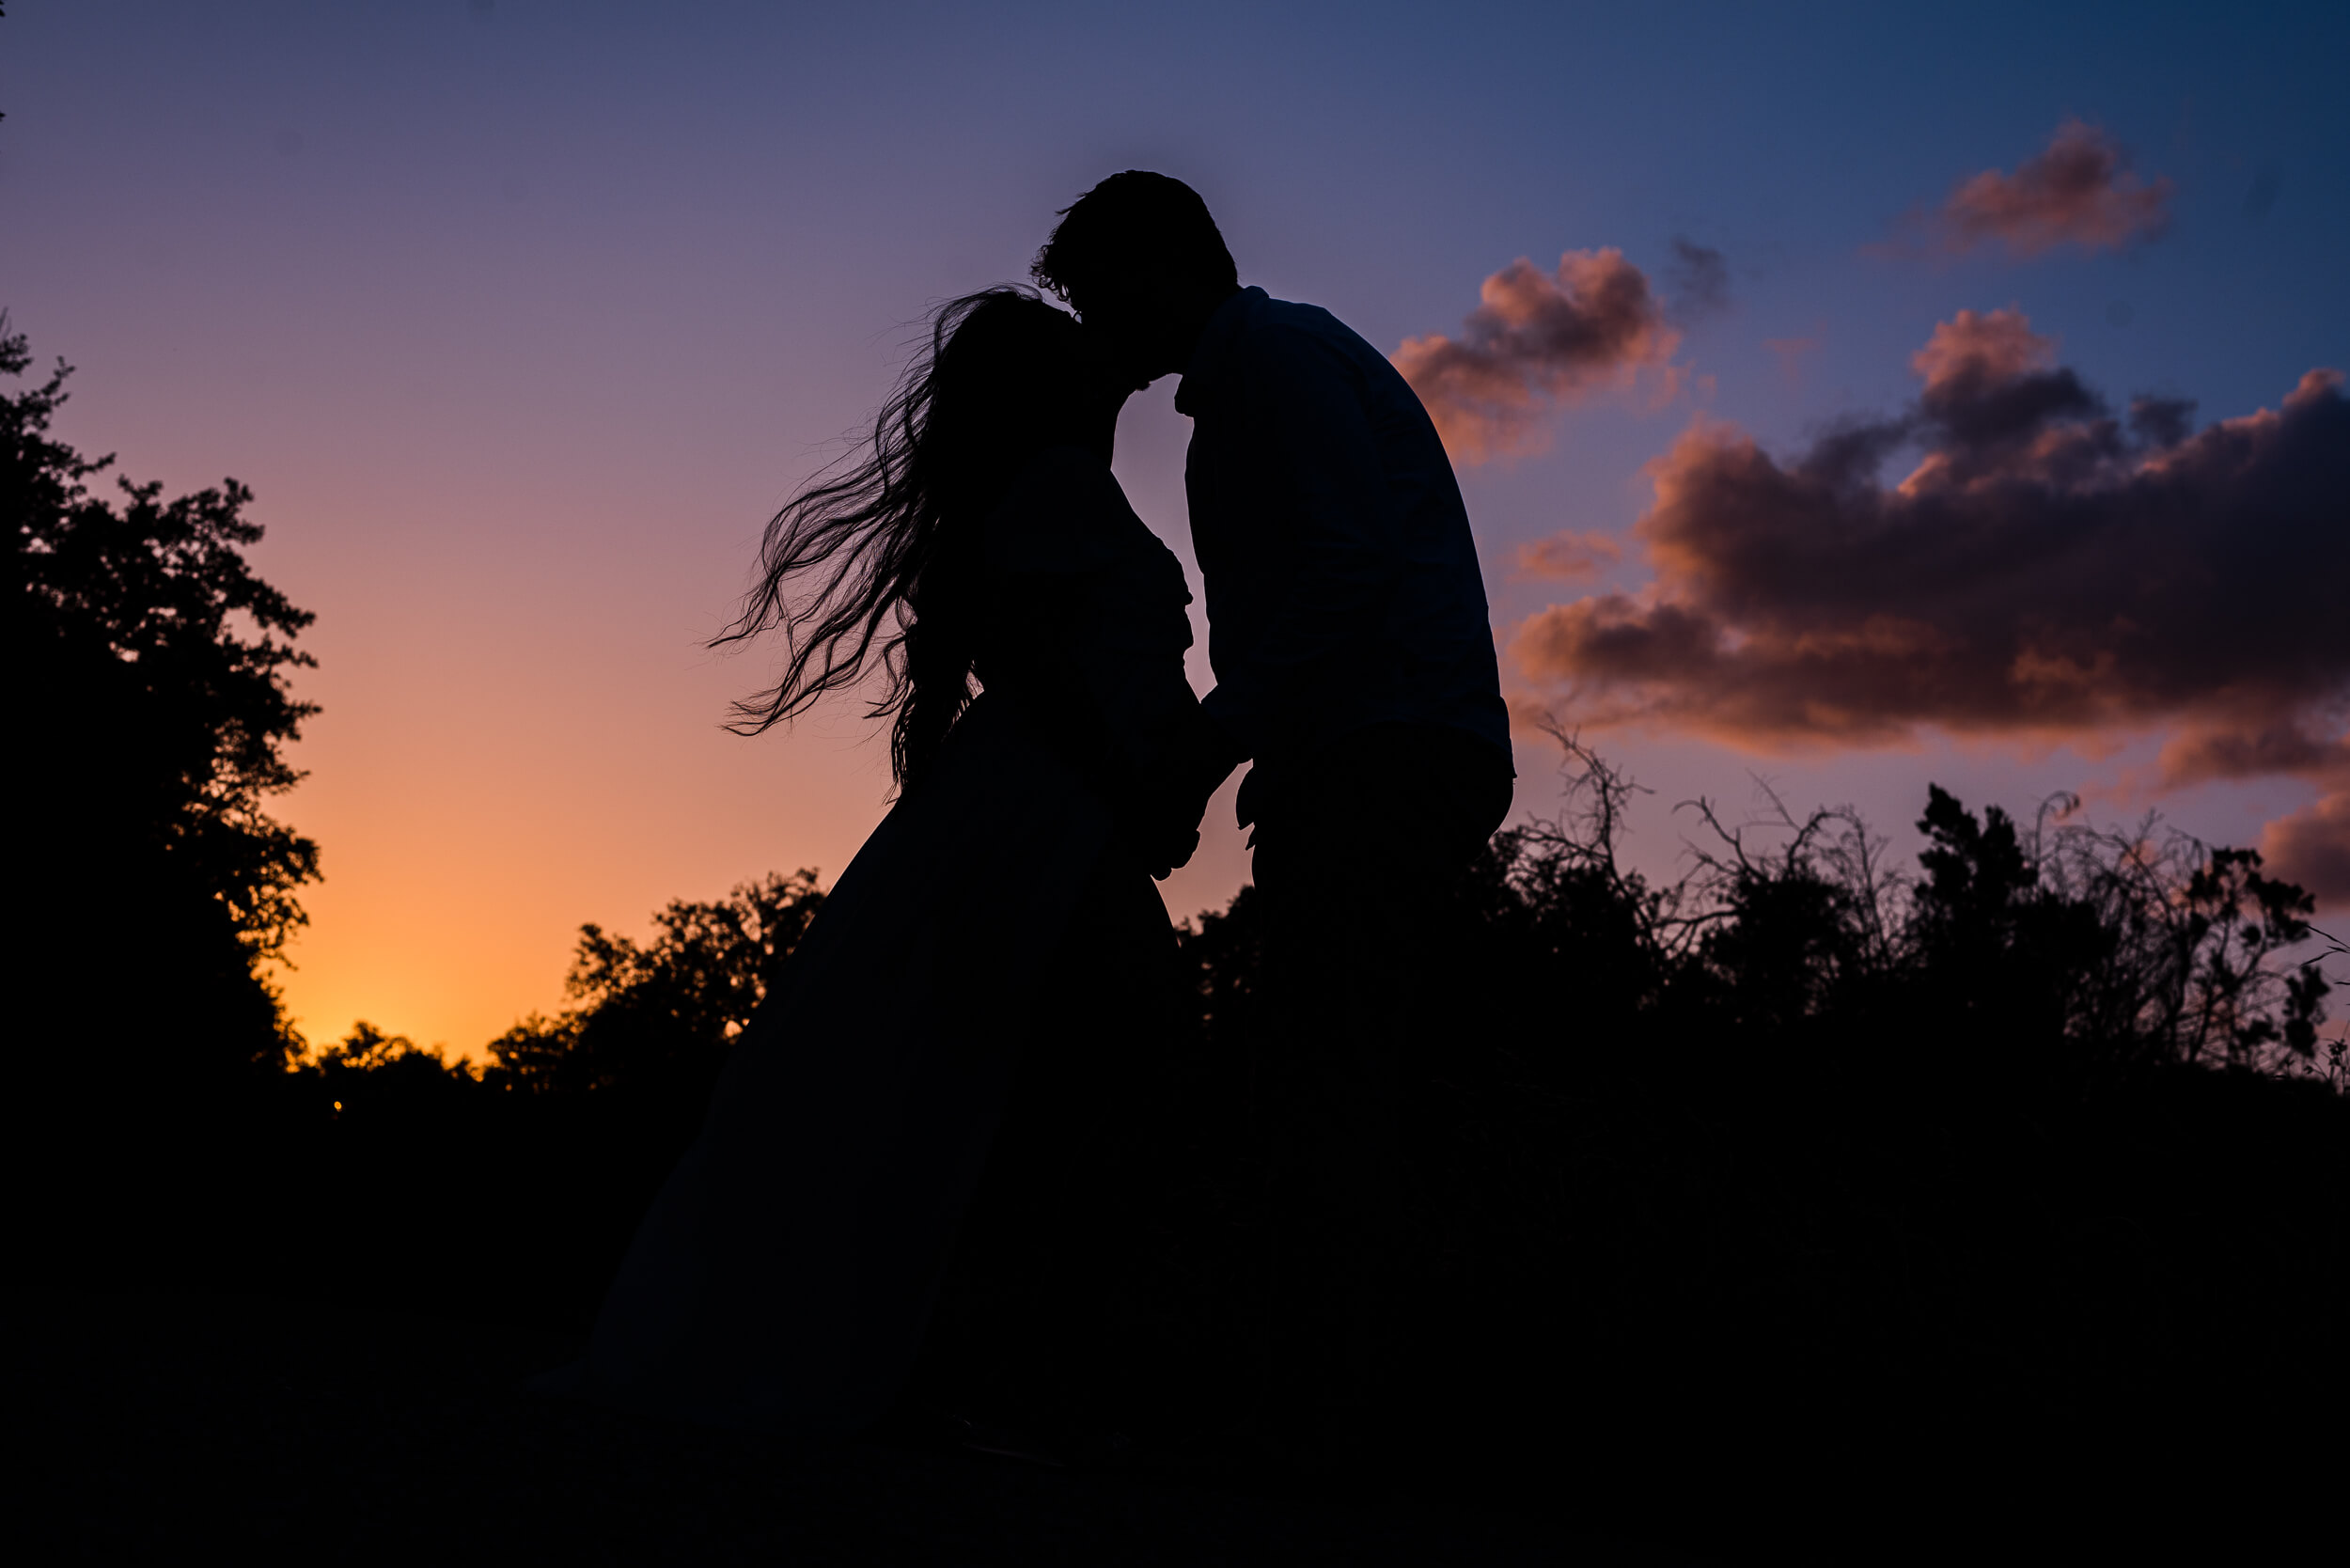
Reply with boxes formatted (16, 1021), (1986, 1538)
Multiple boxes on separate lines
(1512, 310), (2350, 893)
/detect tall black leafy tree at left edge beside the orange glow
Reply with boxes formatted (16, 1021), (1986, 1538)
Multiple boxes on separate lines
(0, 318), (318, 1084)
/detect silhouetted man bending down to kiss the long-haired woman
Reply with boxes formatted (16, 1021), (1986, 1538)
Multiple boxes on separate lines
(1034, 172), (1513, 1460)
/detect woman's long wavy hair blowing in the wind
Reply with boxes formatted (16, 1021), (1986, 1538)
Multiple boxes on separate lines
(710, 287), (1076, 790)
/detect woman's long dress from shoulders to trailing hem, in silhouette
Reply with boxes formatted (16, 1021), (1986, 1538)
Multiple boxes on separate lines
(550, 447), (1197, 1434)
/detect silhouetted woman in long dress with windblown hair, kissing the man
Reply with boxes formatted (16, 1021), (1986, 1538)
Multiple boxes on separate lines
(550, 290), (1201, 1434)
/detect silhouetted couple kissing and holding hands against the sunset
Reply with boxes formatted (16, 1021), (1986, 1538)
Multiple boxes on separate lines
(547, 172), (1512, 1457)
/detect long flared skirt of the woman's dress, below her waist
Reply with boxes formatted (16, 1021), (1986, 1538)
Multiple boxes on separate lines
(559, 696), (1128, 1434)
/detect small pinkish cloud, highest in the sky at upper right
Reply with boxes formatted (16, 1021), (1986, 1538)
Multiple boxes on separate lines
(1927, 120), (2171, 257)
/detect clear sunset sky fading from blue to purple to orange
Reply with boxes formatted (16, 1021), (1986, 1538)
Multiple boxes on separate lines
(0, 0), (2350, 1053)
